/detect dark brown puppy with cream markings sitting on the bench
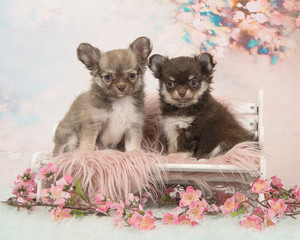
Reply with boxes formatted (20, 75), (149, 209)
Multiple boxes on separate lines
(149, 53), (253, 158)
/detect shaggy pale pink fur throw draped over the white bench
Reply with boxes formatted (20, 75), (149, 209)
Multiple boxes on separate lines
(51, 95), (261, 200)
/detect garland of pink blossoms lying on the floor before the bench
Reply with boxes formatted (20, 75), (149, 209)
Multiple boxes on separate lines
(7, 163), (300, 231)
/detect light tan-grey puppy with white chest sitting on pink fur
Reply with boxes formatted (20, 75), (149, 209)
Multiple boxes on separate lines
(53, 37), (152, 155)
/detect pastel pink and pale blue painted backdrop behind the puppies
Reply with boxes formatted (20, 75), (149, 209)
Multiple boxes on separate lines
(0, 0), (300, 186)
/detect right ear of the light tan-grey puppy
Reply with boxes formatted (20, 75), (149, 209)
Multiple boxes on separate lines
(129, 37), (152, 65)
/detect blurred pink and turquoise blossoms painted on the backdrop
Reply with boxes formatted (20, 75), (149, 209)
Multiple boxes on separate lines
(169, 0), (300, 64)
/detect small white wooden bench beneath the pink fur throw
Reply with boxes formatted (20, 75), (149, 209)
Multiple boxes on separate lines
(32, 90), (265, 199)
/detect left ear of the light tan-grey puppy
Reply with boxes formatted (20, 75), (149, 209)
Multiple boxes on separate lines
(77, 43), (101, 71)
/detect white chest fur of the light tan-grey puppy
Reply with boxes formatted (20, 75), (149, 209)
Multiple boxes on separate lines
(100, 97), (139, 147)
